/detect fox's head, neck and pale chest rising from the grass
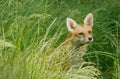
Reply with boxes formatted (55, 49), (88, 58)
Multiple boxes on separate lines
(63, 13), (93, 68)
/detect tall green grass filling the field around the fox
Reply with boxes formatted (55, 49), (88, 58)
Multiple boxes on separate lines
(0, 0), (120, 79)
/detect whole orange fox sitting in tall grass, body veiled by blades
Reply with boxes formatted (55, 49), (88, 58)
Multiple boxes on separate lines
(50, 13), (93, 70)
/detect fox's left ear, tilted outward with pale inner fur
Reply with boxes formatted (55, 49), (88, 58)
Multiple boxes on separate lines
(66, 18), (78, 32)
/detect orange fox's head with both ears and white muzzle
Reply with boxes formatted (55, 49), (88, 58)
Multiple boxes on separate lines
(66, 13), (93, 43)
